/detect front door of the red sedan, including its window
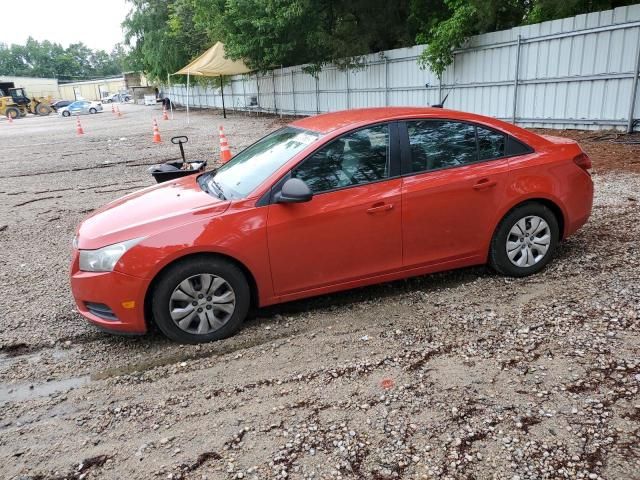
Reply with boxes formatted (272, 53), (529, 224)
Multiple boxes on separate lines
(267, 124), (402, 295)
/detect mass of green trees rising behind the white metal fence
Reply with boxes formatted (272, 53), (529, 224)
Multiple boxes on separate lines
(123, 0), (634, 80)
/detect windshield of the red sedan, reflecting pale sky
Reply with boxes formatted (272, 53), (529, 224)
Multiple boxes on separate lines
(198, 127), (319, 200)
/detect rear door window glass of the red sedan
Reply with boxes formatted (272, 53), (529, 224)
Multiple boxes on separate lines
(407, 120), (478, 173)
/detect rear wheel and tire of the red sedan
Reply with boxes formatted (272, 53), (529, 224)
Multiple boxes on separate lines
(489, 202), (560, 277)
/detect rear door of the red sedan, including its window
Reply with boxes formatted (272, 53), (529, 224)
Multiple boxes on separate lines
(401, 120), (509, 267)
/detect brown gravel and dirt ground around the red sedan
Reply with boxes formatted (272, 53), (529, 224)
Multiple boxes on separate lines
(0, 105), (640, 480)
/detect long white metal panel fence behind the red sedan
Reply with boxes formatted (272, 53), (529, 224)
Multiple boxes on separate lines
(167, 5), (640, 131)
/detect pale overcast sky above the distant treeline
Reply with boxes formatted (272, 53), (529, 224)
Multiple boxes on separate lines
(0, 0), (131, 52)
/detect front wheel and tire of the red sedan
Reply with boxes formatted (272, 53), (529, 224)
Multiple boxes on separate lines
(151, 257), (251, 344)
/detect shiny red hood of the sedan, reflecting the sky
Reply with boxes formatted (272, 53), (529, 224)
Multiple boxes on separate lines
(77, 175), (229, 250)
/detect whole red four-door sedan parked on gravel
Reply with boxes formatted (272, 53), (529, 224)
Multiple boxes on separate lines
(71, 108), (593, 343)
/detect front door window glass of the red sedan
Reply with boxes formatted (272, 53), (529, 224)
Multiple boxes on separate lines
(291, 124), (389, 193)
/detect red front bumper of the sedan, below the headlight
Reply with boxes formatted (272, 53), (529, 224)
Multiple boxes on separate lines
(71, 255), (147, 334)
